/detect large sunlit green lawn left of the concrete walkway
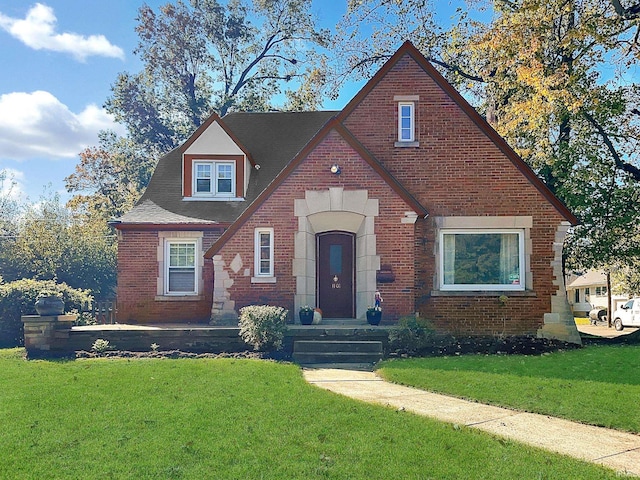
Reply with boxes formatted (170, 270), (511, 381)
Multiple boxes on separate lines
(0, 349), (617, 479)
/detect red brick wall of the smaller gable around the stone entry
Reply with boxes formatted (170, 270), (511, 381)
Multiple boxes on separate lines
(218, 131), (415, 318)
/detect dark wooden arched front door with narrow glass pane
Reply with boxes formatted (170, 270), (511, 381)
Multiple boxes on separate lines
(317, 232), (355, 318)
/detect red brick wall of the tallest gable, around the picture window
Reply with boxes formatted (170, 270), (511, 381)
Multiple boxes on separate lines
(344, 56), (563, 334)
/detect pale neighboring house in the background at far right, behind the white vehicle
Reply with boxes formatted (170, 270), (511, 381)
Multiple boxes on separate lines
(567, 270), (629, 317)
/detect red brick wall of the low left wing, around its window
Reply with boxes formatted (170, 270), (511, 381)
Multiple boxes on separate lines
(117, 230), (222, 323)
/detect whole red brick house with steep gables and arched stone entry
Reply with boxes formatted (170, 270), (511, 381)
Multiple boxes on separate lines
(116, 42), (579, 342)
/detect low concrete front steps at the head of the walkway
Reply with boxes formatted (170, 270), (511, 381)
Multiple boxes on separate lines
(293, 340), (383, 365)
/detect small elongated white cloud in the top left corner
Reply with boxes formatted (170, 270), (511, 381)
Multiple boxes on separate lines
(0, 3), (124, 61)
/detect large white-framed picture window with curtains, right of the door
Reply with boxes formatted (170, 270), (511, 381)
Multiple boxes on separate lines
(439, 229), (525, 291)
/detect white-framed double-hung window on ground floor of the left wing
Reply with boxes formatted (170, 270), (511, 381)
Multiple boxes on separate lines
(164, 239), (198, 295)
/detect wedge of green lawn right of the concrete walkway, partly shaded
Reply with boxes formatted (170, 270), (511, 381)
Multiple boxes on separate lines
(379, 346), (640, 432)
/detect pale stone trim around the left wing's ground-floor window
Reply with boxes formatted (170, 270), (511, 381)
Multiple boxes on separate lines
(155, 231), (204, 302)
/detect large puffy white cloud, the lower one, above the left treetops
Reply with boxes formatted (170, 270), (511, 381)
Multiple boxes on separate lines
(0, 90), (125, 160)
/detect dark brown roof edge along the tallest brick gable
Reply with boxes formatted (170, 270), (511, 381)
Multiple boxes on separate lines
(337, 40), (579, 225)
